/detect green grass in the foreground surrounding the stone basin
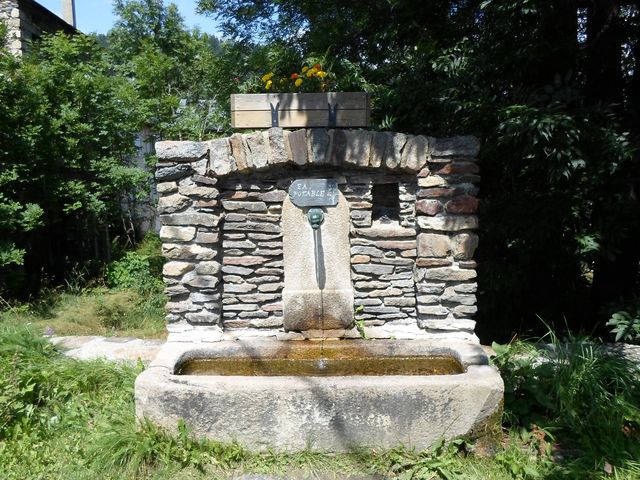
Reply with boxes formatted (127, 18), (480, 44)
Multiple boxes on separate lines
(0, 323), (640, 480)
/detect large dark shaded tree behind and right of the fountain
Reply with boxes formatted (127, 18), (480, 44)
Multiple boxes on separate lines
(199, 0), (640, 338)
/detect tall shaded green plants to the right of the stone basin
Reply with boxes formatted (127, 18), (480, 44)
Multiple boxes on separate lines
(494, 335), (640, 467)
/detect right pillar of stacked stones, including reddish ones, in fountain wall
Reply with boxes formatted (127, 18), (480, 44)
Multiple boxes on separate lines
(414, 137), (480, 339)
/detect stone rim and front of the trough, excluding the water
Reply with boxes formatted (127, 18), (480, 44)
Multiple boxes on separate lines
(136, 338), (503, 452)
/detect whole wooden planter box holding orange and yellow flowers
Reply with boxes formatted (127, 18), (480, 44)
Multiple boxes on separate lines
(231, 92), (370, 128)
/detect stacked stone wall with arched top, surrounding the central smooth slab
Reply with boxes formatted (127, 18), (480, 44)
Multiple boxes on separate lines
(156, 128), (479, 341)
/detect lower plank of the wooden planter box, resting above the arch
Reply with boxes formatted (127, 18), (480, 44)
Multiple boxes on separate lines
(231, 109), (369, 128)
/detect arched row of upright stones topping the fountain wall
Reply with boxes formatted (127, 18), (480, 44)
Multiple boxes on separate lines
(156, 128), (479, 177)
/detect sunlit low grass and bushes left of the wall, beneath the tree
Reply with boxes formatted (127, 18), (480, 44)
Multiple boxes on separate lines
(0, 234), (166, 338)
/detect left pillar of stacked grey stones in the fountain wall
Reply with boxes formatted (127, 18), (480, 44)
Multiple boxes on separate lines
(156, 142), (222, 341)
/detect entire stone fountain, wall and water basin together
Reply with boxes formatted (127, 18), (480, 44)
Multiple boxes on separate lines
(136, 128), (503, 451)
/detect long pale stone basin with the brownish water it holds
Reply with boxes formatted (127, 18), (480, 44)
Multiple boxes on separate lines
(135, 339), (504, 452)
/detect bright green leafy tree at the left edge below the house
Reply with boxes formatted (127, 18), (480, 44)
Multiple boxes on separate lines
(0, 34), (148, 295)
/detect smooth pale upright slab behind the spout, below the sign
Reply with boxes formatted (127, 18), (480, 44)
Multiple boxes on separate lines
(282, 193), (354, 331)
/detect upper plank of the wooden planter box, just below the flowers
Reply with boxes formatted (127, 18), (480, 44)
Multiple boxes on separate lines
(231, 92), (369, 111)
